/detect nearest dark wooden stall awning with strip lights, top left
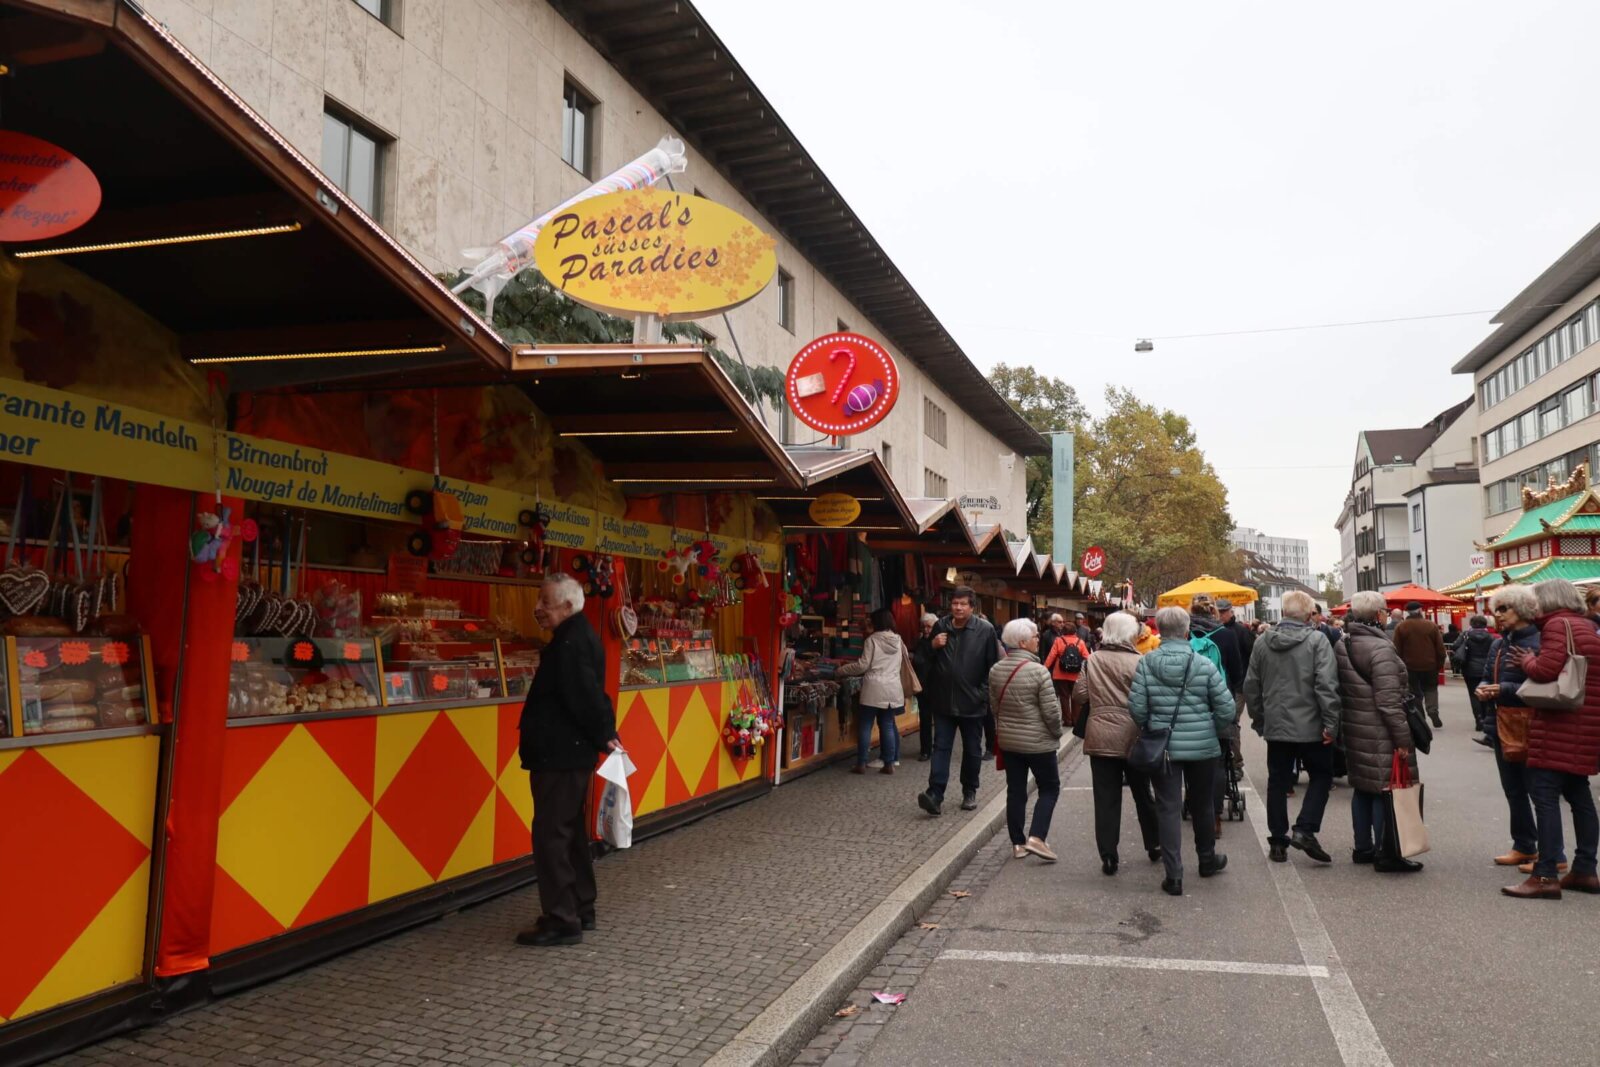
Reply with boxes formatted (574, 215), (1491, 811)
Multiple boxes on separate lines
(0, 0), (510, 390)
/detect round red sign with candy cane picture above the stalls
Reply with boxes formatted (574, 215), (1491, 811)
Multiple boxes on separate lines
(784, 333), (899, 437)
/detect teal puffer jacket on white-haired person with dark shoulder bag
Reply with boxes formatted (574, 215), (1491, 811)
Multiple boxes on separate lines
(1128, 638), (1238, 760)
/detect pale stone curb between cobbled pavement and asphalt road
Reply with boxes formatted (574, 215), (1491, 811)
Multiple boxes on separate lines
(706, 733), (1080, 1067)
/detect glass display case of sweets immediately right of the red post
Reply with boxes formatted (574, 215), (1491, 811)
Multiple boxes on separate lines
(227, 637), (382, 718)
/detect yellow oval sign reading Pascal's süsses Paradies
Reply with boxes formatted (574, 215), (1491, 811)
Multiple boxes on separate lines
(533, 189), (778, 318)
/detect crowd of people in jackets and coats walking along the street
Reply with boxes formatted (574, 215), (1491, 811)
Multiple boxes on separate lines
(902, 581), (1600, 899)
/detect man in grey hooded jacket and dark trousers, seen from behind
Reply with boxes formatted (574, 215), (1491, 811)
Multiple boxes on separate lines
(1245, 590), (1339, 864)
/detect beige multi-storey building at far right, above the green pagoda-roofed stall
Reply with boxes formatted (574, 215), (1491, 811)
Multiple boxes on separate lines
(1451, 217), (1600, 543)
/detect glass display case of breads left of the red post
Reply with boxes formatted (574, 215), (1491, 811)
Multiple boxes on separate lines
(5, 635), (152, 736)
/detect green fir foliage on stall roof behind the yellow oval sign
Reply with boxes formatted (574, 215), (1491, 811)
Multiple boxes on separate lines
(440, 270), (784, 410)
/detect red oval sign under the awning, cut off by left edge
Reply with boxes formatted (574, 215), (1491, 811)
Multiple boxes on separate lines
(0, 130), (101, 243)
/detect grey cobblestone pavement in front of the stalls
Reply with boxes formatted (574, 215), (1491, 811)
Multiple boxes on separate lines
(56, 758), (1003, 1067)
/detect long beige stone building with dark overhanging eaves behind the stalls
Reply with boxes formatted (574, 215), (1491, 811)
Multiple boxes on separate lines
(142, 0), (1048, 533)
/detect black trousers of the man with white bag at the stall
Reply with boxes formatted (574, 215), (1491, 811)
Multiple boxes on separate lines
(528, 771), (597, 931)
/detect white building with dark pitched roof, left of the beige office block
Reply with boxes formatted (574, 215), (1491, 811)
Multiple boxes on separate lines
(1336, 400), (1477, 595)
